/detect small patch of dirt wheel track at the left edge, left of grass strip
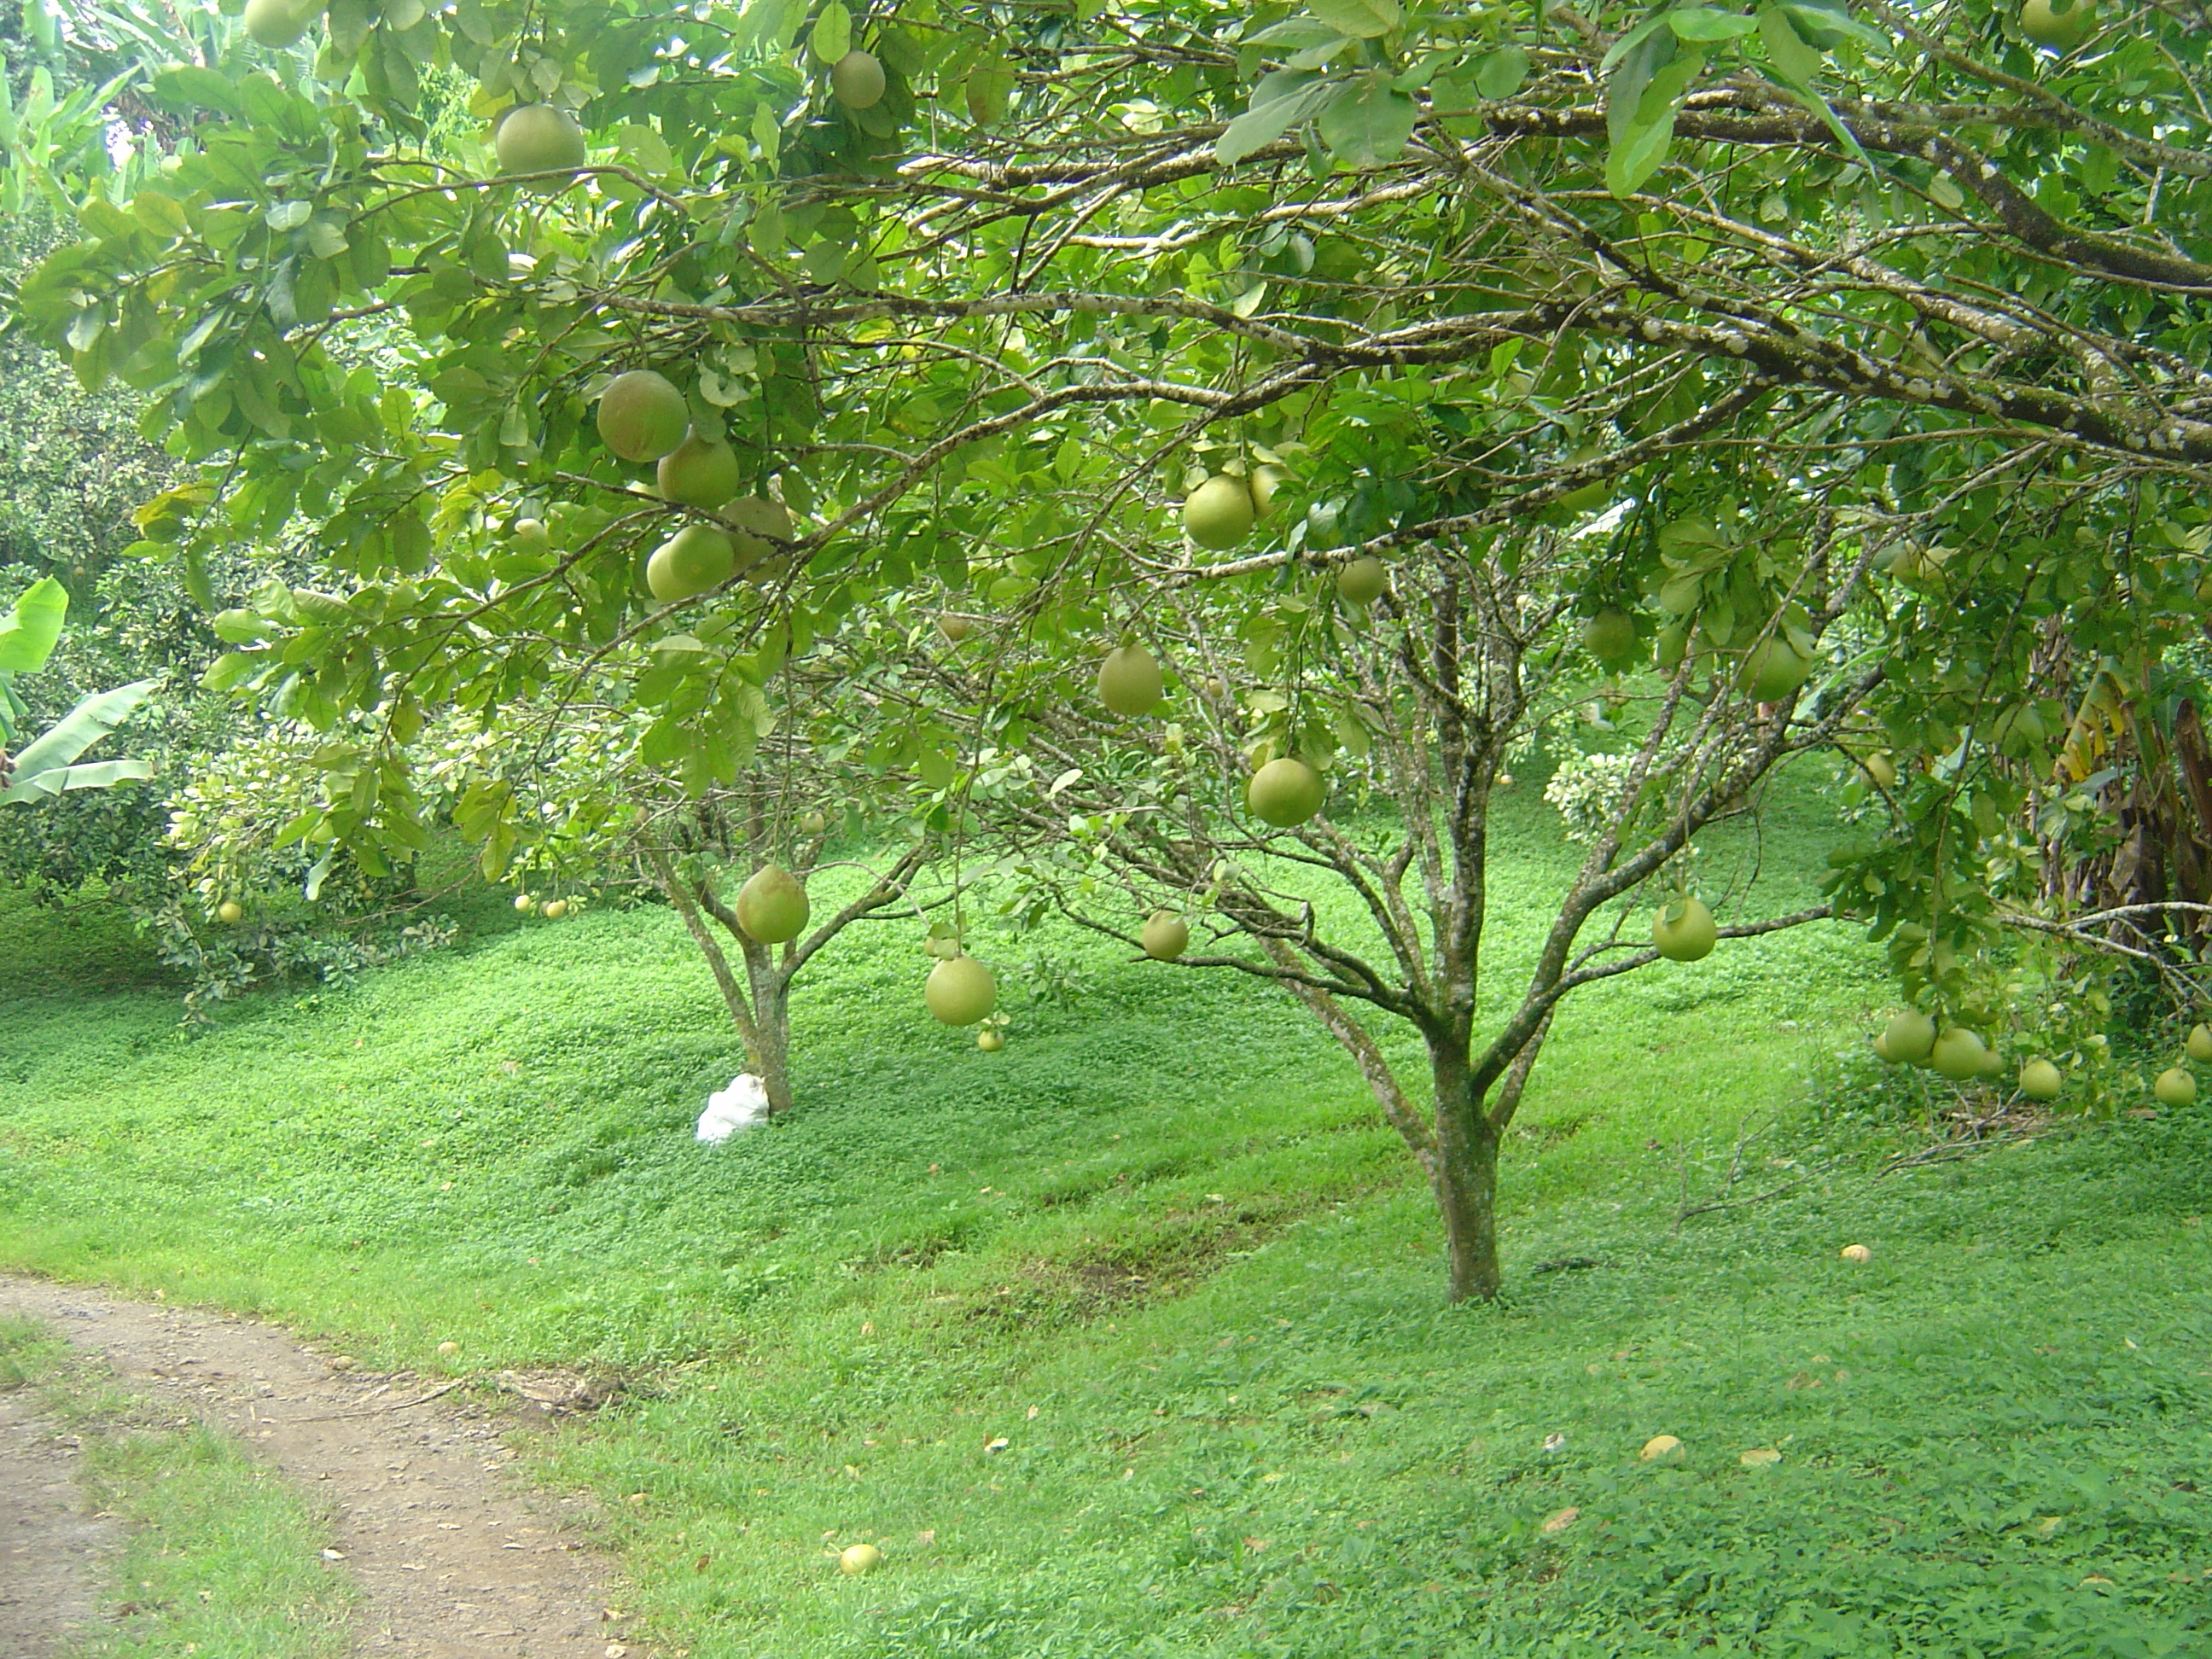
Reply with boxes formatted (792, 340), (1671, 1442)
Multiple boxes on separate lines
(0, 1394), (117, 1659)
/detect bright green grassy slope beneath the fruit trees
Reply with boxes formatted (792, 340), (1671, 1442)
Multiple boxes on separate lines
(0, 789), (2212, 1659)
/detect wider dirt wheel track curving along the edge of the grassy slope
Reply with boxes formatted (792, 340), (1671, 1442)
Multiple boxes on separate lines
(0, 1274), (643, 1659)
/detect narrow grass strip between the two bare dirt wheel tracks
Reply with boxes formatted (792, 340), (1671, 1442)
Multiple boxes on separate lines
(0, 1320), (352, 1659)
